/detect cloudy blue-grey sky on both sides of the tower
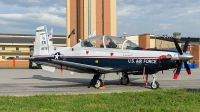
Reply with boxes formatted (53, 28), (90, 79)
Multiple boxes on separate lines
(0, 0), (200, 37)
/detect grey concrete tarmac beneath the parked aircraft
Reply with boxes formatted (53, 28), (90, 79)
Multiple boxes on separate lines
(0, 69), (200, 96)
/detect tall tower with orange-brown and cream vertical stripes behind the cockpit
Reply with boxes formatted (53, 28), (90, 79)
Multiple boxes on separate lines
(66, 0), (117, 46)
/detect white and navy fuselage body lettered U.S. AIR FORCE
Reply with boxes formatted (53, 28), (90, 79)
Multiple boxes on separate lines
(32, 47), (179, 73)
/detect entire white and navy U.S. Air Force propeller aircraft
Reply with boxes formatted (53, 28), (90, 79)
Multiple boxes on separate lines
(8, 25), (193, 89)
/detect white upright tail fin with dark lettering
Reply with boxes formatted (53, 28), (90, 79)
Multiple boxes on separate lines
(33, 26), (49, 56)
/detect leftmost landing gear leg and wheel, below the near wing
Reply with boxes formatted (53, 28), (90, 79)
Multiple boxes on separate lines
(89, 73), (103, 88)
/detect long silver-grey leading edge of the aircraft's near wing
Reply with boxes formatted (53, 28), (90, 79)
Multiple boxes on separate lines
(51, 59), (113, 72)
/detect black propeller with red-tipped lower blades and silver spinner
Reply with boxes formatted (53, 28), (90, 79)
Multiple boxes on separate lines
(173, 37), (193, 79)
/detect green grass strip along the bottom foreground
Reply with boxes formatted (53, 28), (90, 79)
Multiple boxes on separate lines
(0, 89), (200, 112)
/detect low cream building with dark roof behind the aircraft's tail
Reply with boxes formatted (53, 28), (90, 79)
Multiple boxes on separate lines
(0, 34), (66, 60)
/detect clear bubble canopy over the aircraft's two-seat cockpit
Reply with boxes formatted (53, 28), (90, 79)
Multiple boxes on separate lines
(81, 36), (139, 49)
